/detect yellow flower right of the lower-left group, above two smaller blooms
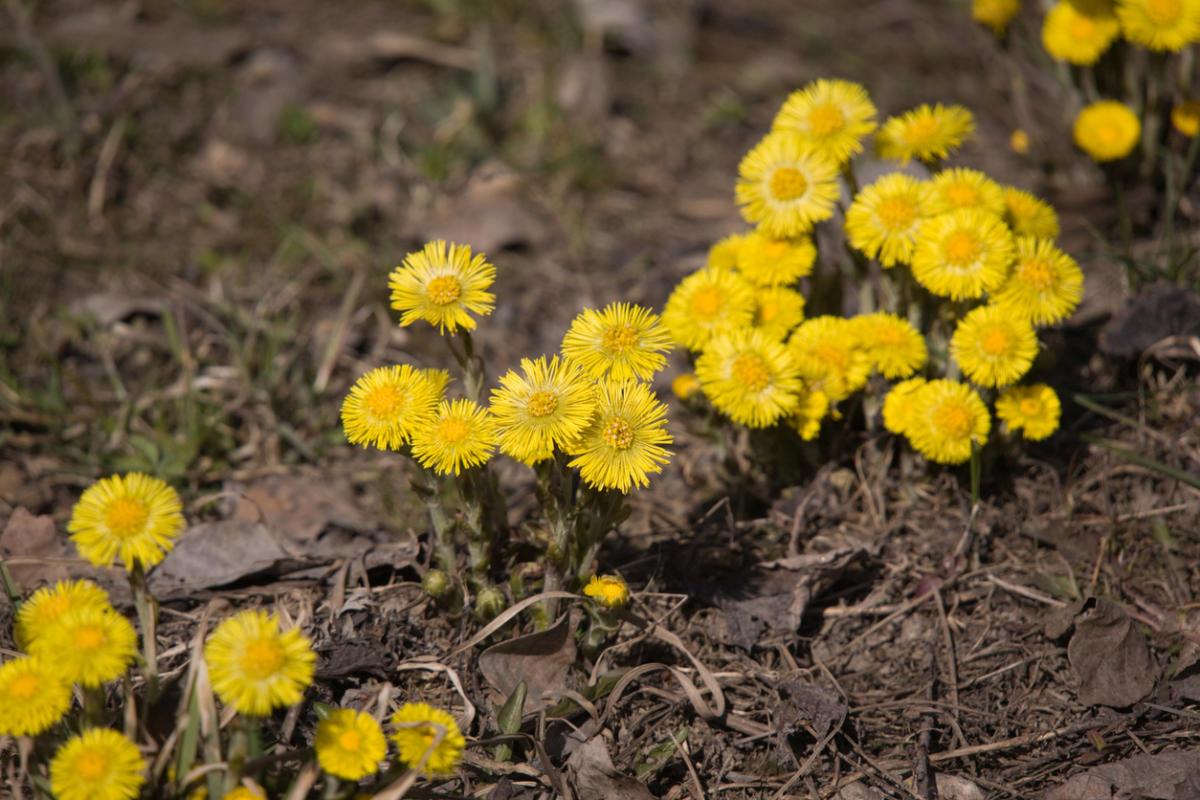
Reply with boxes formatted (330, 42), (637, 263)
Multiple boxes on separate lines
(204, 610), (317, 716)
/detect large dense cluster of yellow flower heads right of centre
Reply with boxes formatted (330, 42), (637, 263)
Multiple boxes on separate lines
(662, 79), (1082, 463)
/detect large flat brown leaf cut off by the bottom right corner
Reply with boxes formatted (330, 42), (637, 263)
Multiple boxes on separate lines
(1044, 750), (1200, 800)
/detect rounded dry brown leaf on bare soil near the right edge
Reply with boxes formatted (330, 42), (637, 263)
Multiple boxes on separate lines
(1067, 600), (1159, 706)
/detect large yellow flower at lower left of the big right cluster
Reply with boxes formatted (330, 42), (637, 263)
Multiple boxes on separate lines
(696, 327), (804, 428)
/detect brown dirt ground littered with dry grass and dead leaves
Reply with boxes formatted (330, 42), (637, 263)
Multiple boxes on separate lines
(0, 0), (1200, 800)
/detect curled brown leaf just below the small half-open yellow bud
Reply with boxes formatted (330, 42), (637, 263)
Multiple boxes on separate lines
(479, 616), (575, 714)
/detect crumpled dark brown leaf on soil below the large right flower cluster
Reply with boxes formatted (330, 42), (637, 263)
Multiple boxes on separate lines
(714, 543), (868, 650)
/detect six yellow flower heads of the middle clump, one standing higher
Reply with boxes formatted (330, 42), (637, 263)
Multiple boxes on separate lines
(342, 241), (676, 493)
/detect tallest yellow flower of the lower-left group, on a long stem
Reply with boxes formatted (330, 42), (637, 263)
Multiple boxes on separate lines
(67, 473), (184, 570)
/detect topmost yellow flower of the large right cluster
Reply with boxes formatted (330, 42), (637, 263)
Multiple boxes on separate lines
(770, 79), (876, 164)
